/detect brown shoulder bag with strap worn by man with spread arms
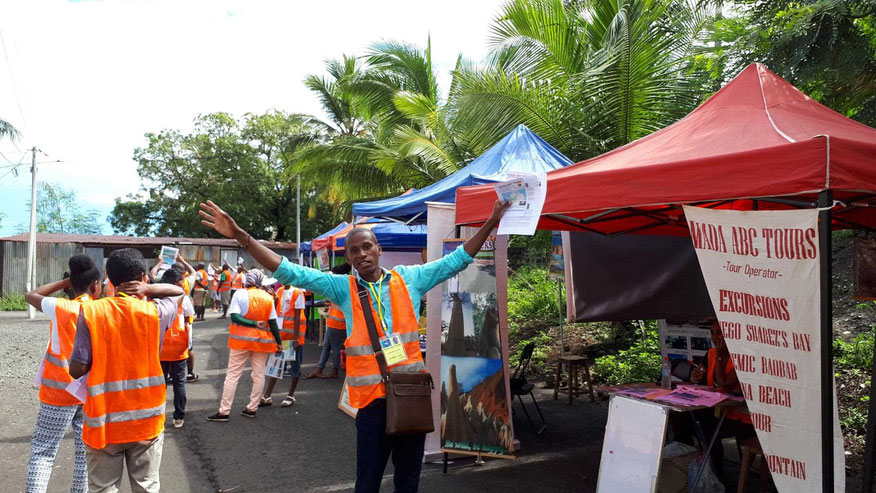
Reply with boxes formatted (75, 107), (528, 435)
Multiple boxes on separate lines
(359, 289), (435, 435)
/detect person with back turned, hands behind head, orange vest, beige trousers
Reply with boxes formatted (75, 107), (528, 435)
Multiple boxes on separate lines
(70, 248), (184, 492)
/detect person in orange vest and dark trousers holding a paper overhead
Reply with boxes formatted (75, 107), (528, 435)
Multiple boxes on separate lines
(158, 267), (195, 428)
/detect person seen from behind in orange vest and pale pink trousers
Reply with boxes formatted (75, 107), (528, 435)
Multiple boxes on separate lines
(207, 270), (283, 422)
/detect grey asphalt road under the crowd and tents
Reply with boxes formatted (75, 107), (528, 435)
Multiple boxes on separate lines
(0, 313), (606, 493)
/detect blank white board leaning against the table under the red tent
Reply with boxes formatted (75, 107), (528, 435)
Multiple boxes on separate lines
(596, 395), (666, 493)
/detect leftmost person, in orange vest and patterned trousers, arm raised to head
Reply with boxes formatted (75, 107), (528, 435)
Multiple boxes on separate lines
(25, 255), (101, 493)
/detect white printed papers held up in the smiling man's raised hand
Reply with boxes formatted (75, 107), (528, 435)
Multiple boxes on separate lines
(493, 173), (547, 235)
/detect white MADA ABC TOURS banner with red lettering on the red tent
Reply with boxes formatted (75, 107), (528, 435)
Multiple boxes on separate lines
(684, 206), (845, 493)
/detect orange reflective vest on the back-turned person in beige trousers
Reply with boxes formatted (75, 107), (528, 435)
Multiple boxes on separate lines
(82, 296), (166, 449)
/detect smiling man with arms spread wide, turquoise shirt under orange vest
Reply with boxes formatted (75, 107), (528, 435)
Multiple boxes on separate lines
(200, 201), (510, 493)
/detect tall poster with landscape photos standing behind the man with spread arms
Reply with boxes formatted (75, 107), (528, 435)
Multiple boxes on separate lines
(441, 238), (514, 457)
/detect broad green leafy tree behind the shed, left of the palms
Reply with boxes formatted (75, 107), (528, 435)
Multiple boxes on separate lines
(109, 112), (335, 241)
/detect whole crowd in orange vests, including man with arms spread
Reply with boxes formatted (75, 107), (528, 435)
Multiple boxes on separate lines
(26, 197), (507, 492)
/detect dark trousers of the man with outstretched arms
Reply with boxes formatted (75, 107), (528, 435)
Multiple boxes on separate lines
(356, 399), (426, 493)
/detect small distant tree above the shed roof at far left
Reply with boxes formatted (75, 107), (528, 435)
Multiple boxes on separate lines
(18, 182), (102, 235)
